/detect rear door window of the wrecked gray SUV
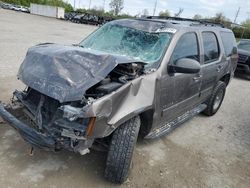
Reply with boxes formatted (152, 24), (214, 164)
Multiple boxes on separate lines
(202, 32), (219, 64)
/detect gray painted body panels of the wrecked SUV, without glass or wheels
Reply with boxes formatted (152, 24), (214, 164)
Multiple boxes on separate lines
(0, 20), (237, 153)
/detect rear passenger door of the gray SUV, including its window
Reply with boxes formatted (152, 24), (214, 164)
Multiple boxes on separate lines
(200, 31), (223, 100)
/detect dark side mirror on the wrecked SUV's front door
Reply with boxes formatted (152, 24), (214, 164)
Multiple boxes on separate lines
(169, 58), (201, 74)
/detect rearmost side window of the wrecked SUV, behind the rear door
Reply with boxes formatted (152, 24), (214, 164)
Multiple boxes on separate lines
(220, 32), (237, 57)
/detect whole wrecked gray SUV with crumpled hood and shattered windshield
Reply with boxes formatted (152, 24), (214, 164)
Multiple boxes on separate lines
(0, 18), (237, 183)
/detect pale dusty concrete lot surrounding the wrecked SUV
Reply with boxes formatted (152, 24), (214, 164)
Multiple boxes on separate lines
(0, 9), (250, 188)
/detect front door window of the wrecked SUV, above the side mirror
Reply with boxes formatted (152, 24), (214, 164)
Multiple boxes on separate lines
(171, 33), (200, 64)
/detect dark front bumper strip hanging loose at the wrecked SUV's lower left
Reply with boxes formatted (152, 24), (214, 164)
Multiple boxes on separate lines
(0, 103), (56, 151)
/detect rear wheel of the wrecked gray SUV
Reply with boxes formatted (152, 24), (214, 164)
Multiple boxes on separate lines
(203, 81), (227, 116)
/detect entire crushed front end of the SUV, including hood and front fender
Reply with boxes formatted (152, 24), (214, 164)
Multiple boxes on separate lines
(0, 44), (156, 155)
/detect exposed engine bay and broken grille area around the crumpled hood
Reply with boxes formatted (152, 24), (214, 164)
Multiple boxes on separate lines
(5, 63), (144, 154)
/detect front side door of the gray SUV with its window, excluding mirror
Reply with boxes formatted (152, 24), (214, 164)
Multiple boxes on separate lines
(161, 32), (202, 122)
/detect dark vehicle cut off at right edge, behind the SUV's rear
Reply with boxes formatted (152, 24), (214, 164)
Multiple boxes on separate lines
(237, 39), (250, 79)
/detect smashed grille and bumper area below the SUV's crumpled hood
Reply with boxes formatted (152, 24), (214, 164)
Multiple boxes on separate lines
(0, 88), (95, 154)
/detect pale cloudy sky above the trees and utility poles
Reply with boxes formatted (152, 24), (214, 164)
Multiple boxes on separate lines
(65, 0), (250, 22)
